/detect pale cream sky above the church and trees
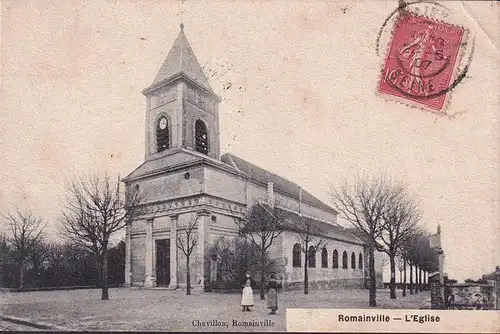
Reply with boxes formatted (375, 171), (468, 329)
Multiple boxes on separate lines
(0, 0), (500, 280)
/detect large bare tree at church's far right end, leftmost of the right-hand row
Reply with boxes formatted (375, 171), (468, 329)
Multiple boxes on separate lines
(330, 177), (391, 306)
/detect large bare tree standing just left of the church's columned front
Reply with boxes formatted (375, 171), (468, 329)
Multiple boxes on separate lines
(60, 174), (140, 300)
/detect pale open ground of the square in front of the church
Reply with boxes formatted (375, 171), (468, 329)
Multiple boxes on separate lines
(0, 288), (428, 332)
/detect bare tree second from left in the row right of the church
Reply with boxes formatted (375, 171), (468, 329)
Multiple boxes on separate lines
(379, 185), (422, 299)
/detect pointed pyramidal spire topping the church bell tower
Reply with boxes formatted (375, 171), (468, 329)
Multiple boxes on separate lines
(153, 23), (212, 91)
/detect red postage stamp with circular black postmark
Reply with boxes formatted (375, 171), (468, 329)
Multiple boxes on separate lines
(378, 14), (465, 111)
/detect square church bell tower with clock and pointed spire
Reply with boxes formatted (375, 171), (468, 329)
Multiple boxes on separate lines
(142, 24), (221, 160)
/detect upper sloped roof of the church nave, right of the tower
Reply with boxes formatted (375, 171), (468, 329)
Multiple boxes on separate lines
(221, 153), (336, 213)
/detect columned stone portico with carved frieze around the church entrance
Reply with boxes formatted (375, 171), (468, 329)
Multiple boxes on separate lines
(127, 195), (245, 289)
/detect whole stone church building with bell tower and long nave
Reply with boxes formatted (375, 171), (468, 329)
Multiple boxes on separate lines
(123, 26), (381, 289)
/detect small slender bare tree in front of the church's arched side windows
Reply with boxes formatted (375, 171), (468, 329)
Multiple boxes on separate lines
(291, 217), (328, 295)
